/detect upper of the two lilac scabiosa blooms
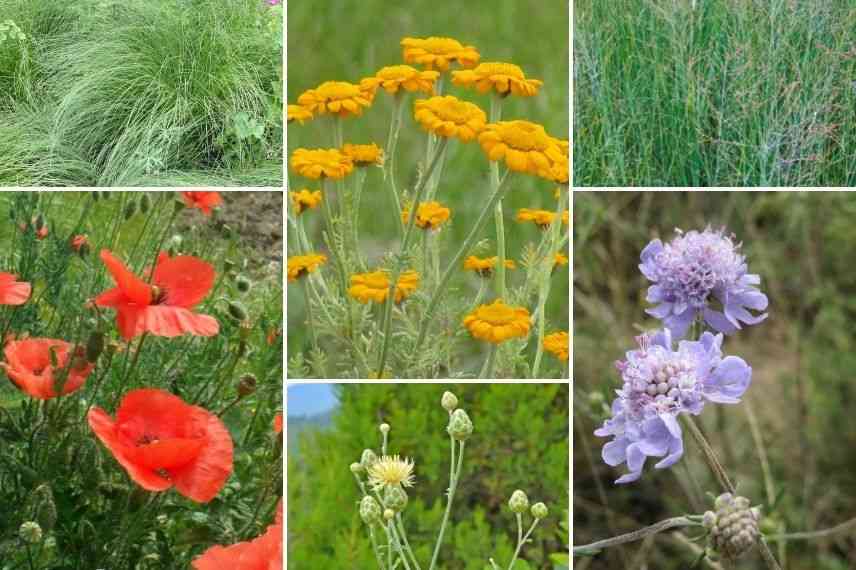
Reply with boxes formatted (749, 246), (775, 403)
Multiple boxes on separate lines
(639, 228), (767, 338)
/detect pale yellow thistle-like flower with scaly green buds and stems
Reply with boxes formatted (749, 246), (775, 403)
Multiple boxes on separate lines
(350, 392), (549, 570)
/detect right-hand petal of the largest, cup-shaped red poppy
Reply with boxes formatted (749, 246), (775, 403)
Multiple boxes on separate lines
(173, 408), (234, 503)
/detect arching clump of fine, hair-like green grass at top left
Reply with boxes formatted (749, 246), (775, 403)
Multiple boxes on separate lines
(0, 0), (282, 186)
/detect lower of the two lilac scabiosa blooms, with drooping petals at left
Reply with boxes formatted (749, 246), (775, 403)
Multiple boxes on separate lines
(594, 329), (752, 484)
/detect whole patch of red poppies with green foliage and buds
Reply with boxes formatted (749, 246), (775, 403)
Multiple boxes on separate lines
(0, 191), (282, 570)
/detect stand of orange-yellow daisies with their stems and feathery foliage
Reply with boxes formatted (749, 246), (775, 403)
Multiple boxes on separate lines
(288, 33), (569, 378)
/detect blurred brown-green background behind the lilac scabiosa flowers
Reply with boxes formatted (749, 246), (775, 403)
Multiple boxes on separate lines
(574, 192), (856, 570)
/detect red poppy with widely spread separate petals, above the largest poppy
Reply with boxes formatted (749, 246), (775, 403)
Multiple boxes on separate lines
(95, 249), (220, 339)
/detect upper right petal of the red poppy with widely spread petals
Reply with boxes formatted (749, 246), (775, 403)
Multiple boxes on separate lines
(154, 255), (215, 309)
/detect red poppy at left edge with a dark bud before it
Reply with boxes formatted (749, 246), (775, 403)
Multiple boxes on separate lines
(0, 338), (94, 400)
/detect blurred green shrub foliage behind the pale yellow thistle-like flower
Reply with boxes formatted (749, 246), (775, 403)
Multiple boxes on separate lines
(288, 384), (569, 570)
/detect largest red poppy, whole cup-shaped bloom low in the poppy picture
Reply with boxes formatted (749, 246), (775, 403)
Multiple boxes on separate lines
(89, 389), (233, 503)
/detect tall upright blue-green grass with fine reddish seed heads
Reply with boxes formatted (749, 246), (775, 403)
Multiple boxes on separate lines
(574, 0), (856, 186)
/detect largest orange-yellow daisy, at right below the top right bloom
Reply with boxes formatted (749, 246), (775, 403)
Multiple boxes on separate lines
(479, 121), (563, 178)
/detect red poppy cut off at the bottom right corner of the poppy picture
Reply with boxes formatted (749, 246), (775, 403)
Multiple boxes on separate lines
(193, 501), (282, 570)
